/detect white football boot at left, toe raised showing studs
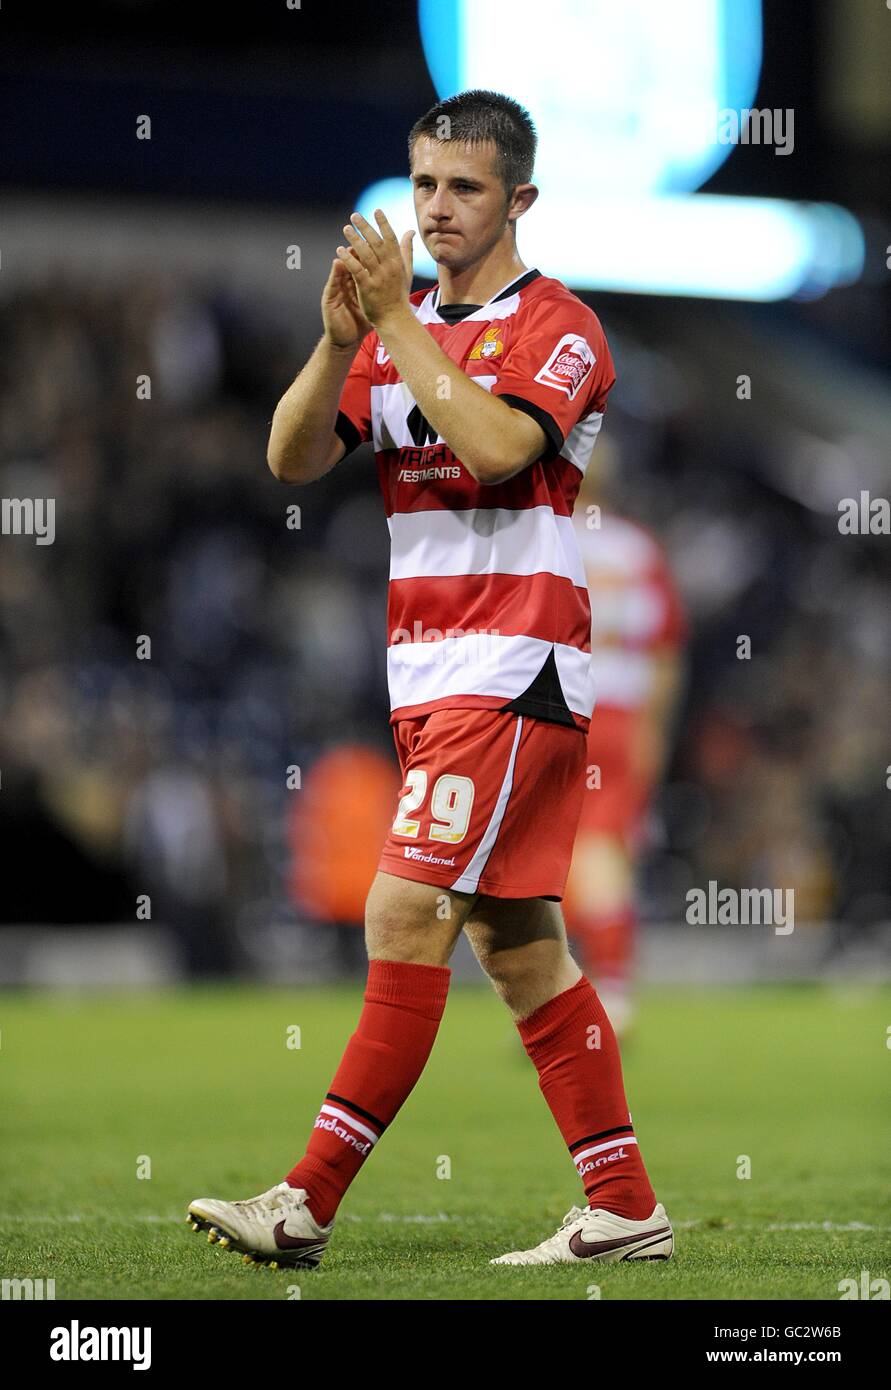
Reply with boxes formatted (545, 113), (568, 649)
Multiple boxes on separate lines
(186, 1182), (334, 1269)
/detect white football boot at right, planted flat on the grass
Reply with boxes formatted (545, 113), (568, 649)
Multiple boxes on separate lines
(489, 1202), (674, 1265)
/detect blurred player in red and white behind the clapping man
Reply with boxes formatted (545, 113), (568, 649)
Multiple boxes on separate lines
(563, 441), (687, 1037)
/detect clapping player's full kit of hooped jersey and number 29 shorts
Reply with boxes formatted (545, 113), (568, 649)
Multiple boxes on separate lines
(335, 270), (616, 901)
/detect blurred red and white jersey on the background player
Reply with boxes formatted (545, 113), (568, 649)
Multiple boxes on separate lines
(573, 510), (687, 709)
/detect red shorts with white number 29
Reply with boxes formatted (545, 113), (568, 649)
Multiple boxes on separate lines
(378, 708), (587, 902)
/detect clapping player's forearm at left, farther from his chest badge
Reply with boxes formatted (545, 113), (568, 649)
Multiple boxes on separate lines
(265, 338), (359, 482)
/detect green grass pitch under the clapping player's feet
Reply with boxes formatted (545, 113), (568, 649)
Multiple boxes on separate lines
(0, 984), (891, 1300)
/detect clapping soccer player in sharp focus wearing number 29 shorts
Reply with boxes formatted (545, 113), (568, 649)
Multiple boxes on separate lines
(189, 90), (674, 1266)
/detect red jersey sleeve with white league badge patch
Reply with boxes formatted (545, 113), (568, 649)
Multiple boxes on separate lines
(492, 299), (616, 460)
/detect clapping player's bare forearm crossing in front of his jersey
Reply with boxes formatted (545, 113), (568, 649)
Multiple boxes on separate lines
(377, 309), (527, 484)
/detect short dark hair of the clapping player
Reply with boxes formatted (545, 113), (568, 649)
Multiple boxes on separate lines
(409, 88), (538, 196)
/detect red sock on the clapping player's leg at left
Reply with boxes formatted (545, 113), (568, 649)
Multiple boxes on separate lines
(285, 960), (452, 1226)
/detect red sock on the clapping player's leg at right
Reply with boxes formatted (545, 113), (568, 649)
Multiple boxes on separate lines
(517, 976), (656, 1220)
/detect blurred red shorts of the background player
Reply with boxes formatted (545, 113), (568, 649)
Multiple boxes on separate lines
(578, 705), (653, 841)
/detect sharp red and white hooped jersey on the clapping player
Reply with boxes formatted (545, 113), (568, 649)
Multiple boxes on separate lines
(335, 270), (616, 730)
